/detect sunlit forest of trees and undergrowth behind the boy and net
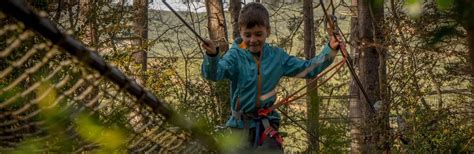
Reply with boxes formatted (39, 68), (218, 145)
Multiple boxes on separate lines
(0, 0), (474, 153)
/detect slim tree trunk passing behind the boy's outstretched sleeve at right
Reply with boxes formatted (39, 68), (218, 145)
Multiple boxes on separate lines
(303, 0), (320, 153)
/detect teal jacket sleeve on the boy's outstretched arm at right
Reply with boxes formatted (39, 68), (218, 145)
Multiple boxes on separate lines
(282, 44), (334, 78)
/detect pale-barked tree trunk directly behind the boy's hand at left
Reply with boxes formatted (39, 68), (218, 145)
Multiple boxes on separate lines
(206, 0), (230, 124)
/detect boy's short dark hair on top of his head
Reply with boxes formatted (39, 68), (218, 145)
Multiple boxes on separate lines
(239, 2), (270, 28)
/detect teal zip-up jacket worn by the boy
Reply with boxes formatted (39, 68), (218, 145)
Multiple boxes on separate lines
(201, 39), (334, 128)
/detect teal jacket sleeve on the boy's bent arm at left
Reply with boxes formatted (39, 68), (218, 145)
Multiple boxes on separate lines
(201, 49), (237, 81)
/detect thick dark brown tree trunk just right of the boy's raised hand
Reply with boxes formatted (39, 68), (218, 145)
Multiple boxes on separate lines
(358, 0), (389, 153)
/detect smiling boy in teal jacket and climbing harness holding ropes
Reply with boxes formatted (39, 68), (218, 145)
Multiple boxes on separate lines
(202, 3), (339, 152)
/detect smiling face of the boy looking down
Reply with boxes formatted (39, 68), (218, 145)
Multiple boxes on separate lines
(240, 25), (270, 53)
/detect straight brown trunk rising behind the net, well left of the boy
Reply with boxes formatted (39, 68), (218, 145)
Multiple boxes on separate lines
(132, 0), (148, 85)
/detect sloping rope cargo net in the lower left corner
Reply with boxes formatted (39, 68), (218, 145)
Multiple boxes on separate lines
(0, 8), (206, 153)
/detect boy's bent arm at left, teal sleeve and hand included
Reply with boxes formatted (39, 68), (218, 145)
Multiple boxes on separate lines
(201, 39), (237, 81)
